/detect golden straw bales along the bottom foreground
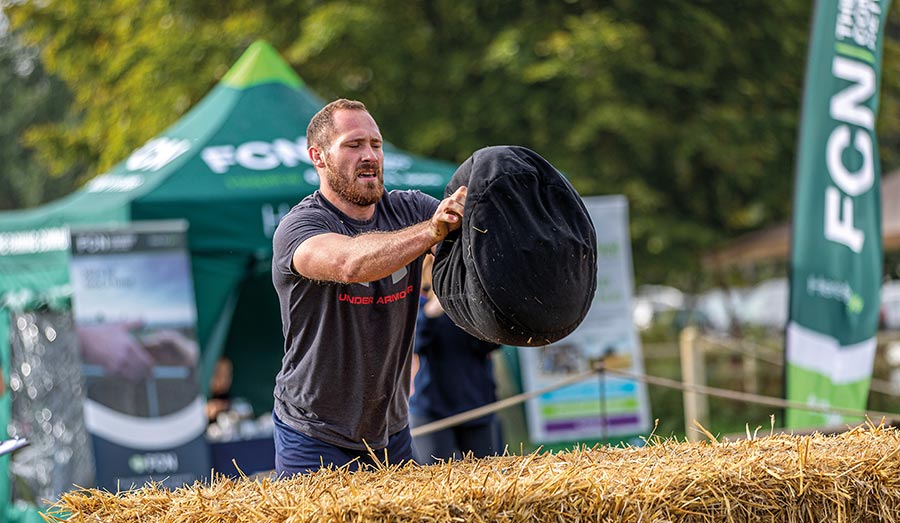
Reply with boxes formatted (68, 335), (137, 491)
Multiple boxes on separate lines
(47, 424), (900, 523)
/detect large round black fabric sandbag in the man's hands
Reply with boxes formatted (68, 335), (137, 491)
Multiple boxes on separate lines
(432, 146), (597, 347)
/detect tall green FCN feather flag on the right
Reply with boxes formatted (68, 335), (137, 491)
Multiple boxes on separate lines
(785, 0), (889, 428)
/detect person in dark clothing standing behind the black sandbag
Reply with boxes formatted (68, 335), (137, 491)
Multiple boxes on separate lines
(409, 260), (500, 465)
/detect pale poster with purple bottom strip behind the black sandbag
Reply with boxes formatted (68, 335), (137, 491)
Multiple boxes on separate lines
(519, 196), (651, 443)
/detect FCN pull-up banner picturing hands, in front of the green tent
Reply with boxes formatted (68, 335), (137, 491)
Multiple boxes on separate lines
(70, 222), (210, 492)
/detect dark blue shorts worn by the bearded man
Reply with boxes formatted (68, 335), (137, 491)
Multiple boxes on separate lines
(272, 412), (412, 476)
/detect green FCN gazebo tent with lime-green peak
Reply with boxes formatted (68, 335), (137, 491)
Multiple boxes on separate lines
(0, 41), (456, 520)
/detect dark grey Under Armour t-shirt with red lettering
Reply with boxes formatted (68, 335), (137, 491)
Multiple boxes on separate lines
(272, 191), (439, 450)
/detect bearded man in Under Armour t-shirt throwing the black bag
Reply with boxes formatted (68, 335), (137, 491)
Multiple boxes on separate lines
(272, 99), (466, 474)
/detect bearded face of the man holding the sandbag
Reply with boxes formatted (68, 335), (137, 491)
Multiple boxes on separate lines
(322, 109), (384, 207)
